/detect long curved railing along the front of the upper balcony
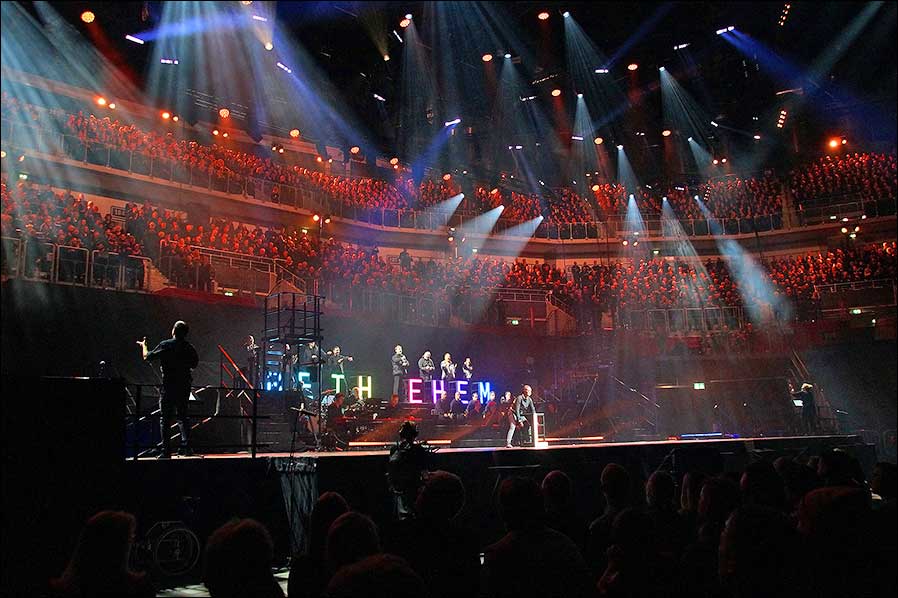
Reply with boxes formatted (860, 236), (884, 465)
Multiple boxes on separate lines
(2, 119), (896, 241)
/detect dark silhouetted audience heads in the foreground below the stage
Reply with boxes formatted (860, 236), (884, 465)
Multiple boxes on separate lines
(50, 449), (896, 598)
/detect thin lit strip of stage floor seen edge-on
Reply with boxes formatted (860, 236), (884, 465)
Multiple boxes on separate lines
(129, 435), (856, 462)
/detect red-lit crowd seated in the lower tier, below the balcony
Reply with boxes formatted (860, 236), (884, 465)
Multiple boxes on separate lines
(0, 181), (896, 324)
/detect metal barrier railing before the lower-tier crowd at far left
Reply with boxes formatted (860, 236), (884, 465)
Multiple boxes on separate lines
(2, 237), (152, 291)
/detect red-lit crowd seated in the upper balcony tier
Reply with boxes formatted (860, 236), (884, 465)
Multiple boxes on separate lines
(2, 93), (896, 229)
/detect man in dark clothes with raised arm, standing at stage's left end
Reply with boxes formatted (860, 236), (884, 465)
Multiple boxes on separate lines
(137, 320), (200, 459)
